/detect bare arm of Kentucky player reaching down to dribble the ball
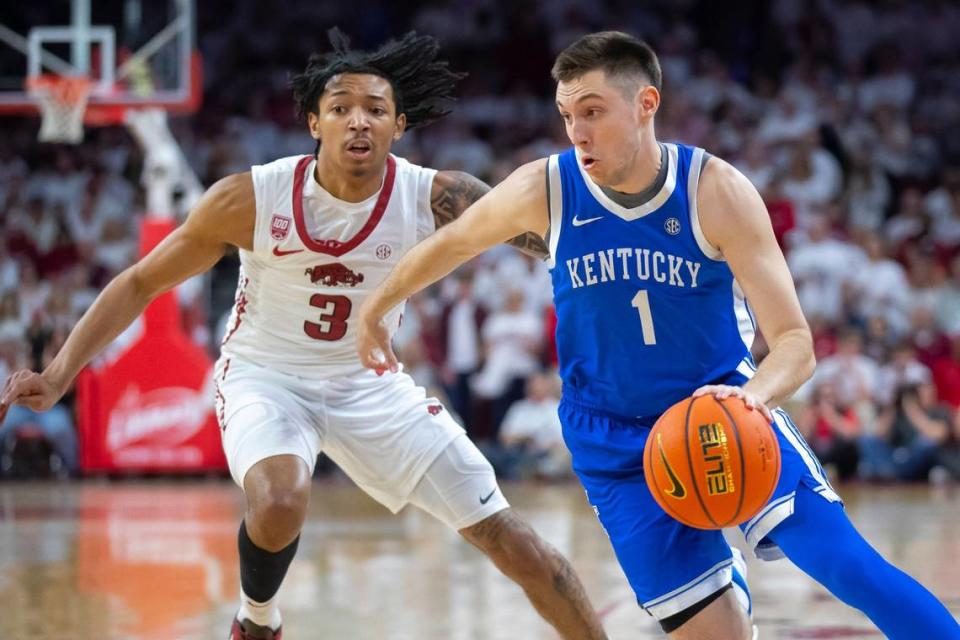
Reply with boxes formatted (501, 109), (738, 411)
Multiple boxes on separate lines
(697, 158), (816, 418)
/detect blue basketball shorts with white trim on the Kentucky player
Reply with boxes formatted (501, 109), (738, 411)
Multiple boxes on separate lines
(560, 399), (840, 620)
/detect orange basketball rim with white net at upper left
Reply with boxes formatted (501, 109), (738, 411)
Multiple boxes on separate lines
(27, 75), (91, 144)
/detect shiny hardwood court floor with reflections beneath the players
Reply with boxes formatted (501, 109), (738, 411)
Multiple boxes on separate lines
(0, 480), (960, 640)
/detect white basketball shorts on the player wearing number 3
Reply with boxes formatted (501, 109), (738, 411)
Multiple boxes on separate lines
(215, 357), (508, 529)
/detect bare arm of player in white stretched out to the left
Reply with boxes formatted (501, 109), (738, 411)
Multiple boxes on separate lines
(0, 173), (255, 422)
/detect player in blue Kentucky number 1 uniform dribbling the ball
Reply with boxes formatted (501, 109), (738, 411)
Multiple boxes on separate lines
(357, 32), (960, 640)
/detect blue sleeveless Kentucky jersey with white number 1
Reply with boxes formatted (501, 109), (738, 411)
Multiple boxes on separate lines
(548, 144), (754, 417)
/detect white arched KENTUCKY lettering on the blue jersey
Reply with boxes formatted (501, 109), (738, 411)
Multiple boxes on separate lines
(566, 247), (700, 289)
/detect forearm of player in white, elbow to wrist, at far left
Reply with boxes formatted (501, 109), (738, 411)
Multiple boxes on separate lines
(43, 269), (152, 393)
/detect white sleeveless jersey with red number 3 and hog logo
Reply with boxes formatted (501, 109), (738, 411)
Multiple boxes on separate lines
(221, 155), (436, 378)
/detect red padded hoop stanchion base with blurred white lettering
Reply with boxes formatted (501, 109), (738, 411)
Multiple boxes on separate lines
(77, 220), (226, 473)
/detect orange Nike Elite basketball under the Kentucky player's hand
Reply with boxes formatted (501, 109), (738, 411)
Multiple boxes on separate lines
(643, 395), (780, 529)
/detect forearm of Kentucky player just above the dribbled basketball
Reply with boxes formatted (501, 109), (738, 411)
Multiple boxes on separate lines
(743, 329), (816, 408)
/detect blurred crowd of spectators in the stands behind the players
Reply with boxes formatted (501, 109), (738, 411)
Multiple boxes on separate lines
(0, 0), (960, 480)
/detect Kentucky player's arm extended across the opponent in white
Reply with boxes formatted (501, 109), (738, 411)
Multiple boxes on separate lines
(357, 159), (549, 371)
